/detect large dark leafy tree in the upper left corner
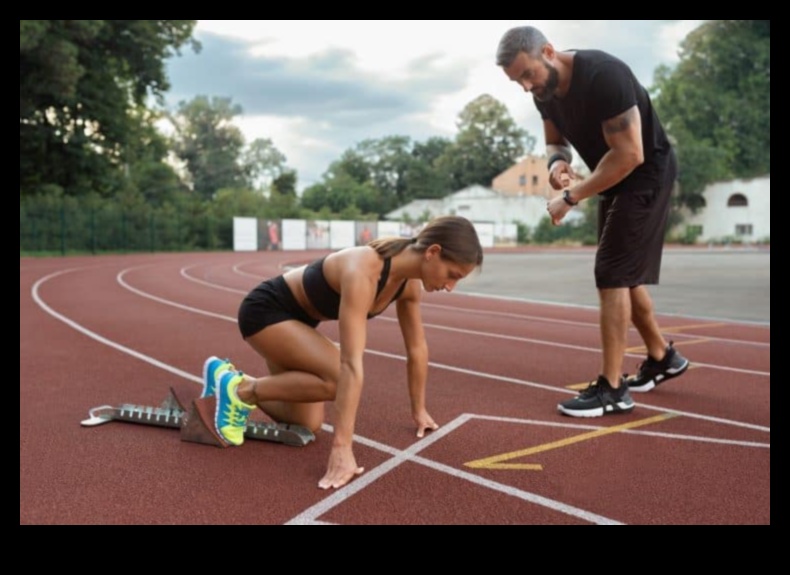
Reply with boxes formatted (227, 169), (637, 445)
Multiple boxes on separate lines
(19, 20), (200, 195)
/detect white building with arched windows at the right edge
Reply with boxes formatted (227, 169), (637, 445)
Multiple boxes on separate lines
(680, 175), (771, 243)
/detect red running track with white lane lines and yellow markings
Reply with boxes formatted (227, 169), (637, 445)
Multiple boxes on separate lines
(19, 252), (771, 525)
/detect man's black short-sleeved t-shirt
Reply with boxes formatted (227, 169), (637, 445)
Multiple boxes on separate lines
(533, 50), (670, 196)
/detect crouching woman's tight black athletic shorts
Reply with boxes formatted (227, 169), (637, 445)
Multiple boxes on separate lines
(238, 276), (321, 338)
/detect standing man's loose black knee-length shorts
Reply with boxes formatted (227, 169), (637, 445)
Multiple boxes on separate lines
(595, 151), (677, 289)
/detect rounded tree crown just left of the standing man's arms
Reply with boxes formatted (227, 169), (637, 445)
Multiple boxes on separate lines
(437, 94), (535, 191)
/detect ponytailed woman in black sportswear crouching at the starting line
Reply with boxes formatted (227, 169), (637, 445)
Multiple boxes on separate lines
(204, 216), (483, 489)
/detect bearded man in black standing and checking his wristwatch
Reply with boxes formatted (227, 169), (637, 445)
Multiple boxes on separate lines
(497, 26), (689, 417)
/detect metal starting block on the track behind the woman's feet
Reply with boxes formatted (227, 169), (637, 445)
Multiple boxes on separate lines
(80, 387), (315, 447)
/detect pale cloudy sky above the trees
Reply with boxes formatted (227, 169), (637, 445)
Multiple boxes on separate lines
(167, 20), (702, 190)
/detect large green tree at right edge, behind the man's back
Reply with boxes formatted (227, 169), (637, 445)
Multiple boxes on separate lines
(653, 20), (771, 209)
